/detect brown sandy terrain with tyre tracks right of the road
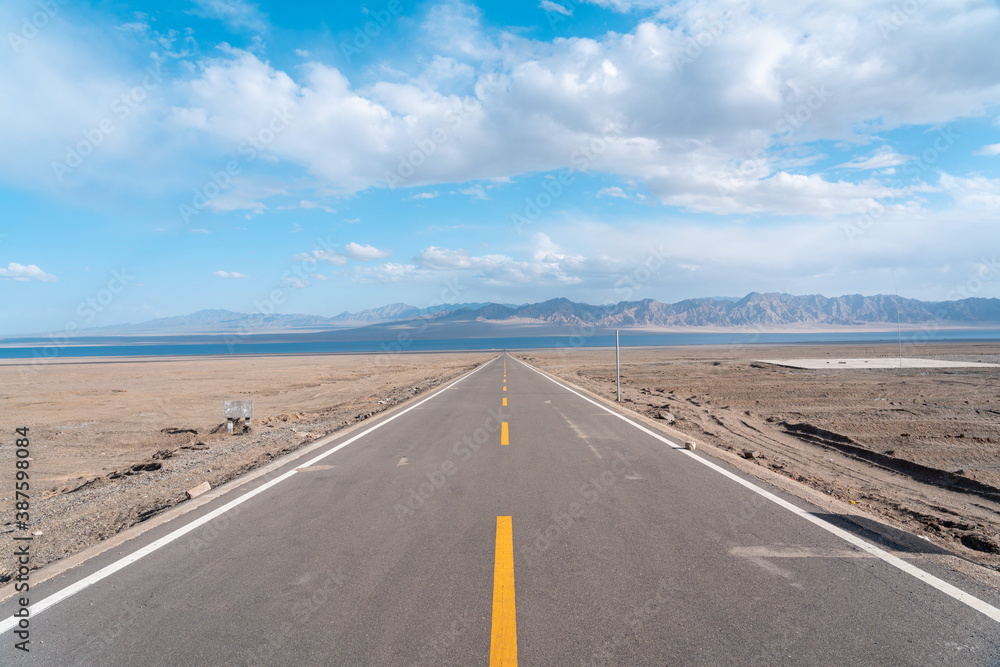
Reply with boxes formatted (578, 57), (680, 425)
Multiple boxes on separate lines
(517, 343), (1000, 570)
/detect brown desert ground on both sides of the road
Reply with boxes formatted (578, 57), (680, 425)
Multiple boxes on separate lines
(0, 343), (1000, 583)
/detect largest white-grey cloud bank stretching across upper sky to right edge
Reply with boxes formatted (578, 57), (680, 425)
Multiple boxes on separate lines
(152, 0), (1000, 215)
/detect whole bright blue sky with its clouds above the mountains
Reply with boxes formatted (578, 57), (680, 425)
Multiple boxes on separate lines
(0, 0), (1000, 334)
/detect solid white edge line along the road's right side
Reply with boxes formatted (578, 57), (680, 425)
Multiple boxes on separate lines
(512, 357), (1000, 623)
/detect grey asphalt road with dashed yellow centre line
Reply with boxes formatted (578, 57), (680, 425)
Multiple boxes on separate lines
(0, 356), (1000, 665)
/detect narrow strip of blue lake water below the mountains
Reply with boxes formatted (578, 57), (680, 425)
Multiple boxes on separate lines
(0, 329), (1000, 359)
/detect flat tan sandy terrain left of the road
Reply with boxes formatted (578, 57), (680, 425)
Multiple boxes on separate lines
(0, 352), (496, 582)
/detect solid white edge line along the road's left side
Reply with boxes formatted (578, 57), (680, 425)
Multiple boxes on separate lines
(0, 357), (500, 634)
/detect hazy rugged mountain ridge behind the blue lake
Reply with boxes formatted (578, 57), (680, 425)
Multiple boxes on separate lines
(80, 292), (1000, 334)
